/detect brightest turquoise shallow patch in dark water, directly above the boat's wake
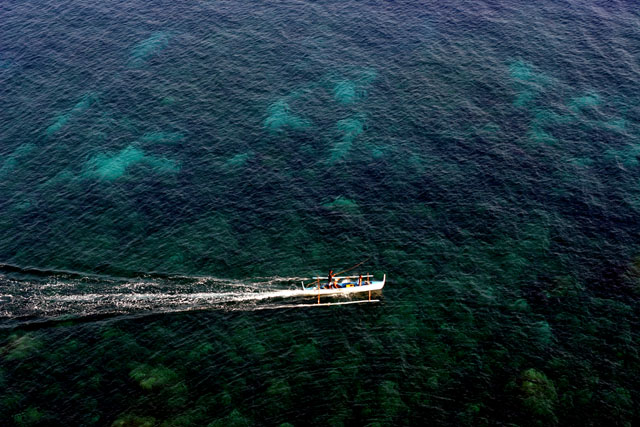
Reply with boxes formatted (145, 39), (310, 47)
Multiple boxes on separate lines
(85, 145), (180, 181)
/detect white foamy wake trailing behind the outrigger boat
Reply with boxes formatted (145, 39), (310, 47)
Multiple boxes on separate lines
(0, 271), (376, 328)
